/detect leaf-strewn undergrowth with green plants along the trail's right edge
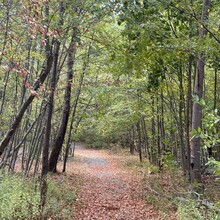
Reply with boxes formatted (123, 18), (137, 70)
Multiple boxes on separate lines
(127, 161), (220, 220)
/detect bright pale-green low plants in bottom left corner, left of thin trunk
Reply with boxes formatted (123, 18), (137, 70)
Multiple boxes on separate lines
(0, 174), (40, 220)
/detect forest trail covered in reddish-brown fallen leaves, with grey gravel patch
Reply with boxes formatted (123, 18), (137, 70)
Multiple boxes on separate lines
(67, 144), (159, 220)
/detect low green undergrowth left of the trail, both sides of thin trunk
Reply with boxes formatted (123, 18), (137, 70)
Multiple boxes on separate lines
(0, 173), (76, 220)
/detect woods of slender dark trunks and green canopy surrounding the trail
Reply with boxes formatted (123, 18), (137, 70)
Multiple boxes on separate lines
(0, 0), (220, 218)
